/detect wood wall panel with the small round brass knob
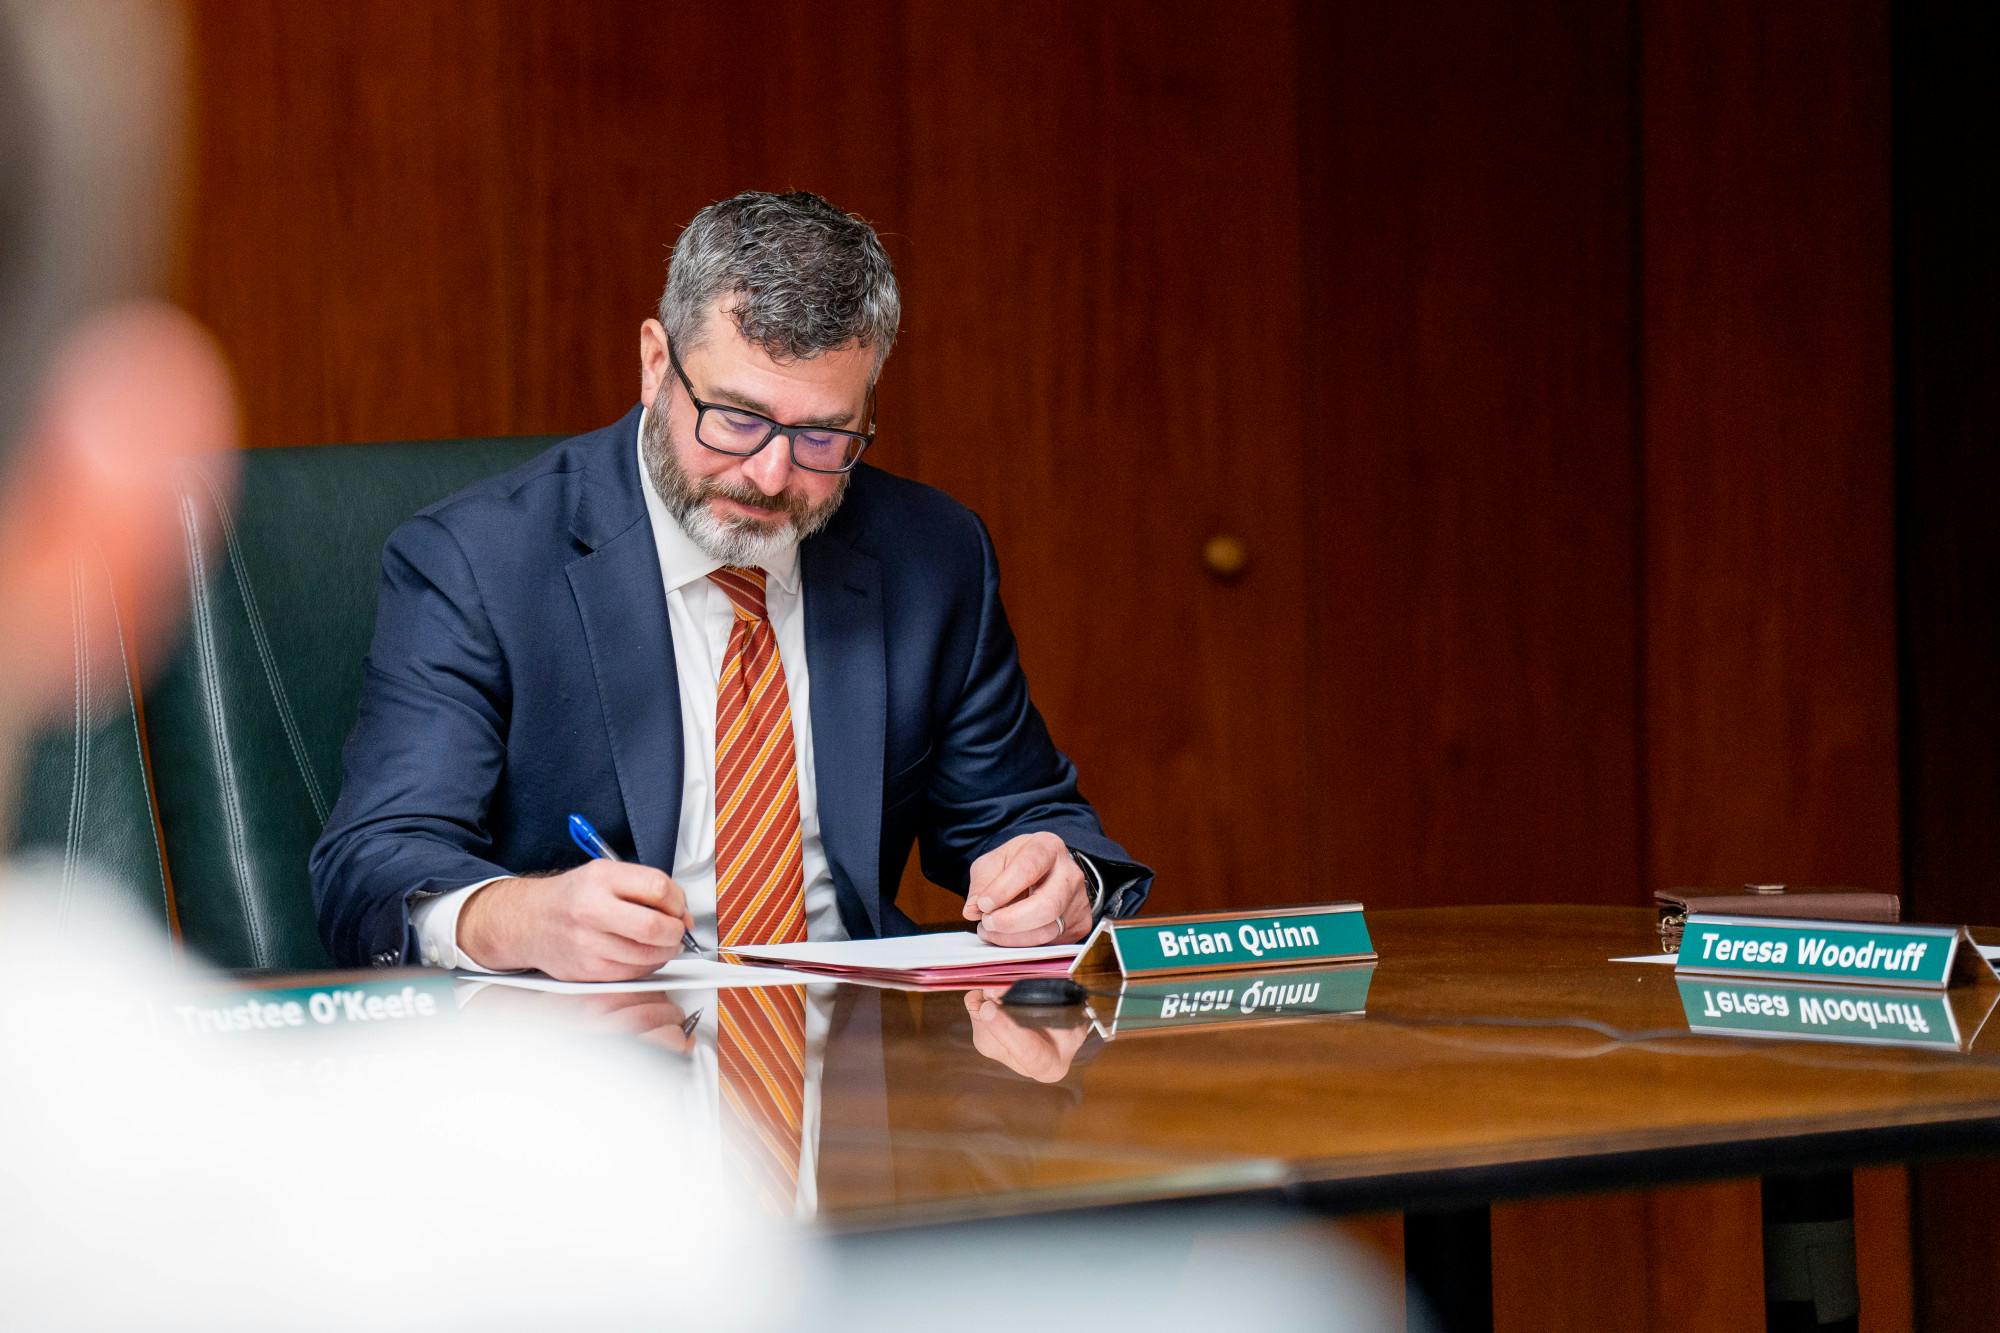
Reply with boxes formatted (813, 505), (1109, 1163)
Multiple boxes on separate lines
(906, 0), (1340, 909)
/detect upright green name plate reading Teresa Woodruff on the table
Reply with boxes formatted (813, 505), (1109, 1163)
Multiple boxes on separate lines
(1676, 915), (1994, 991)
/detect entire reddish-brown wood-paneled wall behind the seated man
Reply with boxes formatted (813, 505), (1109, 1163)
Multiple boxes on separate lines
(168, 0), (1904, 1329)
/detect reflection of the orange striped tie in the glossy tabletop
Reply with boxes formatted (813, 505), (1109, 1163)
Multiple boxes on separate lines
(716, 987), (806, 1217)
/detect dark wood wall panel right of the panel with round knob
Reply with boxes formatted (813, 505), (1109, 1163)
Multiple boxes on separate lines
(1300, 4), (1638, 905)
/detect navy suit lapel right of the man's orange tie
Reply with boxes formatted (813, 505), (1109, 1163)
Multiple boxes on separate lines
(798, 532), (888, 935)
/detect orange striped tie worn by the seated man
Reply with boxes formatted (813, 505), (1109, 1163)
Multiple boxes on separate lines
(710, 566), (806, 949)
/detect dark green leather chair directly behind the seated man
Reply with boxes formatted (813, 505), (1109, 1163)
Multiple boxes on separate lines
(144, 436), (554, 969)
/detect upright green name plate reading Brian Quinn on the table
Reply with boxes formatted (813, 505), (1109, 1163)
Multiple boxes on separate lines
(1070, 903), (1376, 977)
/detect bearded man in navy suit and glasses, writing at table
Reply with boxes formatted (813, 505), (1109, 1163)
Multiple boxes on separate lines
(312, 194), (1152, 981)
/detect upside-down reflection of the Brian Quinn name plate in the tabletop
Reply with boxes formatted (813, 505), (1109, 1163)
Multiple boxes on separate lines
(1090, 963), (1374, 1041)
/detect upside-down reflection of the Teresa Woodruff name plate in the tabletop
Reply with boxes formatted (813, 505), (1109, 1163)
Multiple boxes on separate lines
(1676, 977), (1962, 1051)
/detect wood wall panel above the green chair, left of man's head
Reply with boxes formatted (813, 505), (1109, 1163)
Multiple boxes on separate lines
(178, 0), (906, 444)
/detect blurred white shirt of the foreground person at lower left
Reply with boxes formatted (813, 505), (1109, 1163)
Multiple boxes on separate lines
(0, 875), (818, 1333)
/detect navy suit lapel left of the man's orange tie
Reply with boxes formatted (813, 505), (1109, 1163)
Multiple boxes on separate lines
(566, 408), (682, 871)
